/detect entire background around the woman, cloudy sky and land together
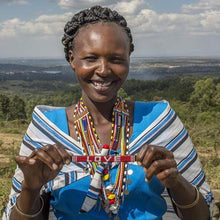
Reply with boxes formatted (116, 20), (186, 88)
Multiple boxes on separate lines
(0, 0), (220, 220)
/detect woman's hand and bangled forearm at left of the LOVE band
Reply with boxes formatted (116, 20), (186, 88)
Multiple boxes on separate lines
(10, 145), (70, 220)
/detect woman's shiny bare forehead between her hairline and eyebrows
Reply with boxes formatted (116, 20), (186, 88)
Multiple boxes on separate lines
(74, 22), (130, 51)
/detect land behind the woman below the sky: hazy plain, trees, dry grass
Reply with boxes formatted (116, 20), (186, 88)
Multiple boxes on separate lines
(0, 57), (220, 219)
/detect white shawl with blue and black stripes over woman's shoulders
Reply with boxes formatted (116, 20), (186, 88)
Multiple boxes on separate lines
(3, 102), (214, 220)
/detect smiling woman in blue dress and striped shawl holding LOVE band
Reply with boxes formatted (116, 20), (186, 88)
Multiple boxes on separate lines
(5, 6), (213, 220)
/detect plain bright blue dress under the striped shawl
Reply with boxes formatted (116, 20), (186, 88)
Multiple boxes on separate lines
(44, 102), (167, 220)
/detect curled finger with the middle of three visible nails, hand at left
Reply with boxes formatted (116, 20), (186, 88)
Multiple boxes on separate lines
(34, 148), (58, 170)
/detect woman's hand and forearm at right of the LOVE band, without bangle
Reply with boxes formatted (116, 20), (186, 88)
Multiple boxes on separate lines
(137, 145), (209, 220)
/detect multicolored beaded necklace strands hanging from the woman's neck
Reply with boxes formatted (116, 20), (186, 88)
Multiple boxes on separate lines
(74, 97), (130, 219)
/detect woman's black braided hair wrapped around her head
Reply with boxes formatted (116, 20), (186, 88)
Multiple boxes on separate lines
(62, 6), (134, 62)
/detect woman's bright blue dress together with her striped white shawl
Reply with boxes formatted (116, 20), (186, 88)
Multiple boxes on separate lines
(3, 101), (214, 220)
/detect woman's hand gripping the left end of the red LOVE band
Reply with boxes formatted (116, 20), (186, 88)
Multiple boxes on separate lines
(15, 144), (71, 190)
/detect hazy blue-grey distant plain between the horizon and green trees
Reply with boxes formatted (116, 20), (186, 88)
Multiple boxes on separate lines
(0, 58), (220, 83)
